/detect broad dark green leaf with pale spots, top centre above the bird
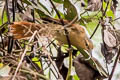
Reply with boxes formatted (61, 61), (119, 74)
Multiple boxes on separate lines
(64, 0), (78, 21)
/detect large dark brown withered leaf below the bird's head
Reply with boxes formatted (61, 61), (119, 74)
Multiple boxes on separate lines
(73, 55), (108, 80)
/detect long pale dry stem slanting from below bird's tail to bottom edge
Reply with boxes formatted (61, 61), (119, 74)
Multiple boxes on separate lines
(12, 31), (37, 80)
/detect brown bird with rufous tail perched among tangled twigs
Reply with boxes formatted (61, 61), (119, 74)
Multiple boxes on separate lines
(9, 21), (93, 50)
